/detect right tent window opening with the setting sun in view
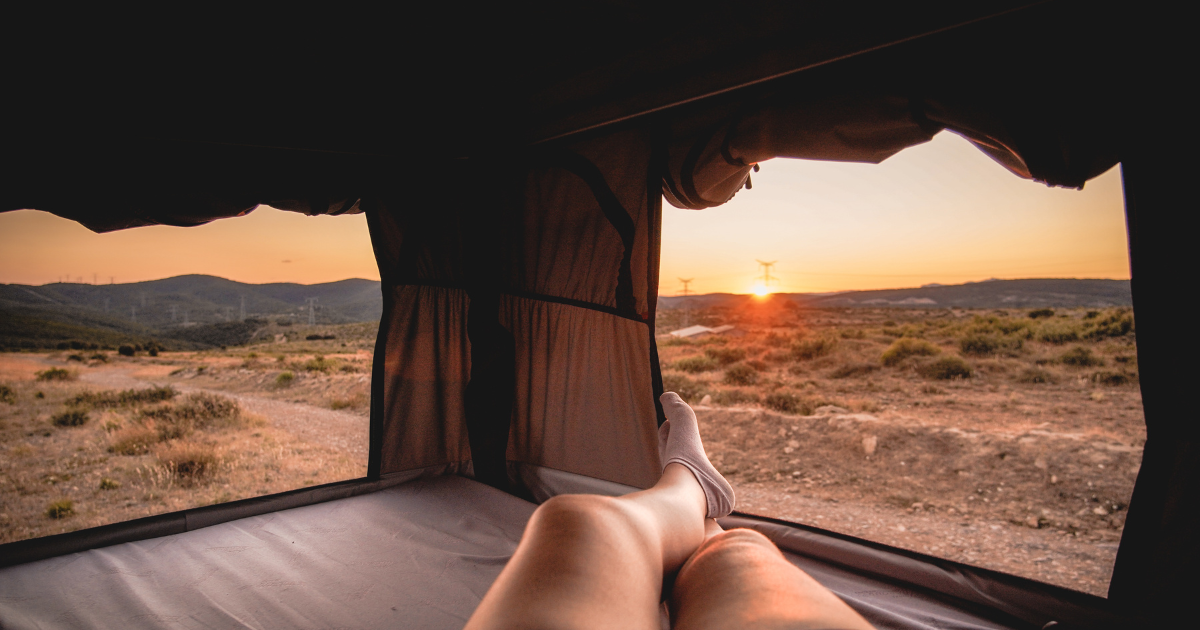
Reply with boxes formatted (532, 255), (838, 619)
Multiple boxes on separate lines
(658, 133), (1145, 596)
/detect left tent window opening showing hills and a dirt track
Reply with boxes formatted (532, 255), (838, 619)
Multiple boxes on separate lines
(0, 206), (383, 542)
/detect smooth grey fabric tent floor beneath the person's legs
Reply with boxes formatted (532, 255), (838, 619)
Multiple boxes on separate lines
(0, 476), (1113, 629)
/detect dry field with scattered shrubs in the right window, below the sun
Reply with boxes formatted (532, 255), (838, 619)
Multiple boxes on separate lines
(659, 300), (1145, 595)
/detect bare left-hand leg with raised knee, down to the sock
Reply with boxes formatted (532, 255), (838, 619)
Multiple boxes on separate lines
(467, 463), (710, 630)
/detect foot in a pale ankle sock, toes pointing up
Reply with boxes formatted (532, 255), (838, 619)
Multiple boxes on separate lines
(659, 391), (734, 518)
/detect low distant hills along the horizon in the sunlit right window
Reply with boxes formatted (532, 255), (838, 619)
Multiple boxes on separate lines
(659, 278), (1133, 308)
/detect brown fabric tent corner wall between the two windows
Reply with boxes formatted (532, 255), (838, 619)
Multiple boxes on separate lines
(364, 128), (661, 487)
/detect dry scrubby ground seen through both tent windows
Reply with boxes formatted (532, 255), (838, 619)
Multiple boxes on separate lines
(0, 299), (1145, 595)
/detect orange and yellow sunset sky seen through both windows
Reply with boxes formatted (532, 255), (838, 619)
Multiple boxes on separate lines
(0, 133), (1129, 295)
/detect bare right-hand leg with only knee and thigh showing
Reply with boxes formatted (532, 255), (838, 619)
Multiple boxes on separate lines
(671, 523), (872, 630)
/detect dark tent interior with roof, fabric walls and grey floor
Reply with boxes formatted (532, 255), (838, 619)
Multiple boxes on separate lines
(0, 1), (1200, 628)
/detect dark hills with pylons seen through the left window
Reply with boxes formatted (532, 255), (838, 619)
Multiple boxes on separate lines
(0, 275), (383, 349)
